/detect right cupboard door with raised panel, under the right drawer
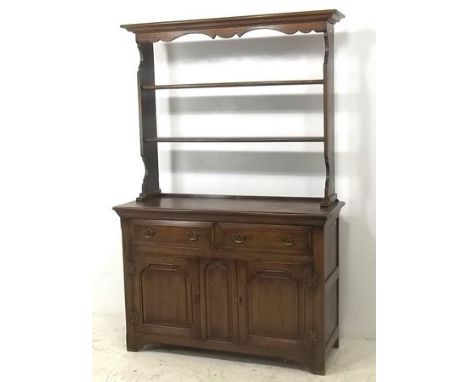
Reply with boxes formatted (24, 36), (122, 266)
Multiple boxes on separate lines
(238, 261), (310, 348)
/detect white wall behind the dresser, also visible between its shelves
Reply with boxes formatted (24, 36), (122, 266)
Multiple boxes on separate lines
(89, 1), (375, 338)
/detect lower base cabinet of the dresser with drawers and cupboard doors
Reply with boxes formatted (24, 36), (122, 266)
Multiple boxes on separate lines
(114, 194), (343, 374)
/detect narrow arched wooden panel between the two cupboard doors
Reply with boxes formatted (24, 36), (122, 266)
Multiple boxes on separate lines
(200, 259), (238, 342)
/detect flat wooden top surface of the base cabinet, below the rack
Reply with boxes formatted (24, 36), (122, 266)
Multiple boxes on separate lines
(114, 194), (344, 219)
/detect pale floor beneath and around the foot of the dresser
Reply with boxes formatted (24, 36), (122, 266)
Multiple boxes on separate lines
(93, 316), (375, 382)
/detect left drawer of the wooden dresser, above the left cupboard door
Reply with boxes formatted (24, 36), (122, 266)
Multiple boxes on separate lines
(131, 220), (213, 248)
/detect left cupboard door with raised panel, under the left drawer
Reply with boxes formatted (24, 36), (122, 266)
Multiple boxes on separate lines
(135, 254), (200, 338)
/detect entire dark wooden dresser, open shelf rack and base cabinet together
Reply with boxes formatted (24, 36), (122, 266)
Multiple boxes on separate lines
(114, 10), (344, 374)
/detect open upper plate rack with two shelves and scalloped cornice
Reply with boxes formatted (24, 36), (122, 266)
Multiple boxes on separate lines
(122, 9), (344, 208)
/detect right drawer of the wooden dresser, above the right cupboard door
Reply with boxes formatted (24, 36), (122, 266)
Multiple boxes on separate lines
(216, 223), (311, 253)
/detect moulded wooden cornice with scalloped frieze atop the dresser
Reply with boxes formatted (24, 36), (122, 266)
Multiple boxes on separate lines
(121, 9), (344, 42)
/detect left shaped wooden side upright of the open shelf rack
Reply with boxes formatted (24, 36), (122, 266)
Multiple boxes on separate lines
(137, 42), (161, 201)
